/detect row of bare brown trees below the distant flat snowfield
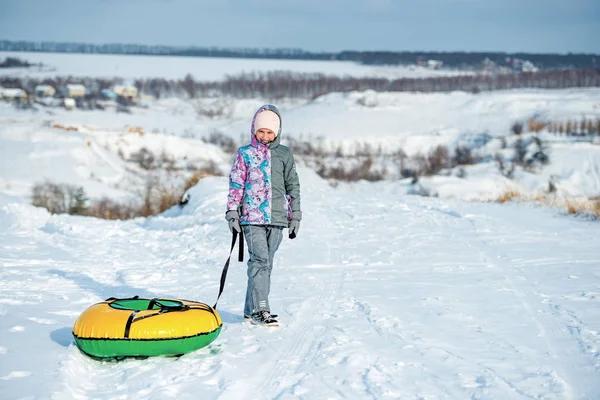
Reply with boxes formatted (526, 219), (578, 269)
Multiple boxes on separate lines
(0, 68), (600, 101)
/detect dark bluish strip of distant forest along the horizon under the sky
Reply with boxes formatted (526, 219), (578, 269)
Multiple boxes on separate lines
(0, 40), (600, 70)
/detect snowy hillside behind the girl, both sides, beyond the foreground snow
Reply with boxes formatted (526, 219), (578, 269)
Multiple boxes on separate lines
(0, 89), (600, 205)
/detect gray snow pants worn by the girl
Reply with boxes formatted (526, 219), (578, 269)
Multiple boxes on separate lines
(242, 225), (283, 315)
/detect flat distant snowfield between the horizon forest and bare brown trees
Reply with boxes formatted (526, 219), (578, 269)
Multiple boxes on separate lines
(0, 52), (470, 81)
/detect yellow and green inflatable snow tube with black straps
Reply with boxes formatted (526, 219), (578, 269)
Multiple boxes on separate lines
(73, 296), (223, 359)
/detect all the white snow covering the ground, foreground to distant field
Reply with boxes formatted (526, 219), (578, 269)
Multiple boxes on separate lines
(0, 53), (600, 400)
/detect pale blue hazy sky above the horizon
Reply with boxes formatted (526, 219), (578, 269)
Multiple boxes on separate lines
(0, 0), (600, 53)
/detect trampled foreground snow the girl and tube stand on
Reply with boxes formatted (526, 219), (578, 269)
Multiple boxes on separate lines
(0, 168), (600, 399)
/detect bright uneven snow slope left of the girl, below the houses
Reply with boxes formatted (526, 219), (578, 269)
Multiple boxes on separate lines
(0, 104), (230, 199)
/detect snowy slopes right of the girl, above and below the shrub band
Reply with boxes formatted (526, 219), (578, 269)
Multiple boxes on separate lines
(223, 89), (600, 200)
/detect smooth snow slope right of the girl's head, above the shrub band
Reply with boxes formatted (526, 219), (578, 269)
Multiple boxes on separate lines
(228, 89), (600, 155)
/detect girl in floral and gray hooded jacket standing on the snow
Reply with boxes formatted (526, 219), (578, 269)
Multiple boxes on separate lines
(225, 105), (302, 326)
